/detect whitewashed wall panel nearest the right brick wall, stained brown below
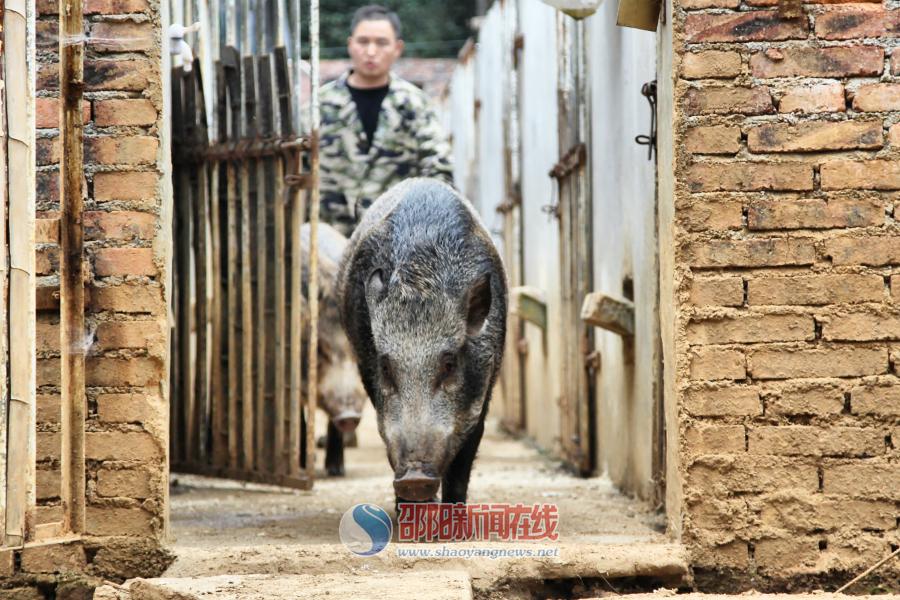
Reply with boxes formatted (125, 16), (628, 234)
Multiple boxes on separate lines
(588, 0), (659, 497)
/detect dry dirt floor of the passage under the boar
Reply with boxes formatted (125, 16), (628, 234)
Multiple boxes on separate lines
(148, 407), (687, 599)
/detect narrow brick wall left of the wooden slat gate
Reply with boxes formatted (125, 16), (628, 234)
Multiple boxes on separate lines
(22, 0), (168, 576)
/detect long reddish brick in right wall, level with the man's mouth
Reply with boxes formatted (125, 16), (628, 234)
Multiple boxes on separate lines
(750, 46), (884, 79)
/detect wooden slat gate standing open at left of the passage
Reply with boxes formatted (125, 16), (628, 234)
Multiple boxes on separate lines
(170, 0), (318, 489)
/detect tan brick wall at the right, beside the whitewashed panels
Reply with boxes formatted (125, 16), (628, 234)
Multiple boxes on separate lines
(673, 0), (900, 579)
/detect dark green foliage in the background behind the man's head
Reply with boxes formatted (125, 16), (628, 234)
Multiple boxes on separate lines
(303, 0), (476, 58)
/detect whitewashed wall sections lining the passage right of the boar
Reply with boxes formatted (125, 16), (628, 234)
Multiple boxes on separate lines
(448, 0), (658, 497)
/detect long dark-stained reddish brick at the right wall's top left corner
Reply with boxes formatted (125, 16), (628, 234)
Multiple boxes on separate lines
(684, 10), (808, 42)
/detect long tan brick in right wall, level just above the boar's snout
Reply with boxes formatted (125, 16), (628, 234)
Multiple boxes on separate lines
(748, 425), (884, 457)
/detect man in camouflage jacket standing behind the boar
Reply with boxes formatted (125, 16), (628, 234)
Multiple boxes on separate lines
(319, 4), (453, 236)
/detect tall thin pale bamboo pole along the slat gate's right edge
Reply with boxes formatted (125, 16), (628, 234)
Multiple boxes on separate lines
(306, 0), (320, 481)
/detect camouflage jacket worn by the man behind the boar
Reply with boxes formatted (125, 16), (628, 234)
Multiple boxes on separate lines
(319, 73), (453, 235)
